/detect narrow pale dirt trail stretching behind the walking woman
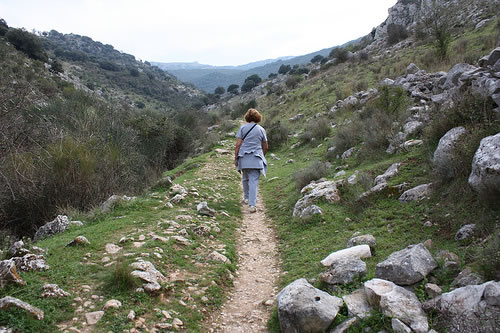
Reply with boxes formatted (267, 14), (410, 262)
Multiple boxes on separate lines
(210, 192), (280, 333)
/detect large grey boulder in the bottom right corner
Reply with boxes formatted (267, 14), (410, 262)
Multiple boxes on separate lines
(424, 281), (500, 333)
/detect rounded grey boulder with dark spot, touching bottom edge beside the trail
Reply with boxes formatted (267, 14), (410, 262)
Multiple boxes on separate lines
(277, 279), (344, 333)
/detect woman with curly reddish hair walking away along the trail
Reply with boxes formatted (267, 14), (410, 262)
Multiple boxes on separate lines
(234, 109), (268, 213)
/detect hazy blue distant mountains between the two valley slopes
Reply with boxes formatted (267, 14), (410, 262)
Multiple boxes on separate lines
(151, 39), (359, 93)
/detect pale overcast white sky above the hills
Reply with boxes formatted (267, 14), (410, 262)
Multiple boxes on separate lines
(0, 0), (397, 66)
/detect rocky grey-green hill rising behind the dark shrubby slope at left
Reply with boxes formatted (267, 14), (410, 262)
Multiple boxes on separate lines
(41, 30), (204, 111)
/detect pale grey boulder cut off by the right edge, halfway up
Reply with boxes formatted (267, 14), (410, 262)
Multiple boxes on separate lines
(469, 133), (500, 194)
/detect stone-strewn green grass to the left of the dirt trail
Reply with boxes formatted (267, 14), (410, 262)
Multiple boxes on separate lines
(0, 141), (241, 332)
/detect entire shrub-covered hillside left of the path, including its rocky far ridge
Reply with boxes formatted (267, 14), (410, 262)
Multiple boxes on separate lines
(0, 20), (210, 244)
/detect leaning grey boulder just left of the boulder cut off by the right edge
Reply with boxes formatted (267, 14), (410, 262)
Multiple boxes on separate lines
(432, 127), (467, 178)
